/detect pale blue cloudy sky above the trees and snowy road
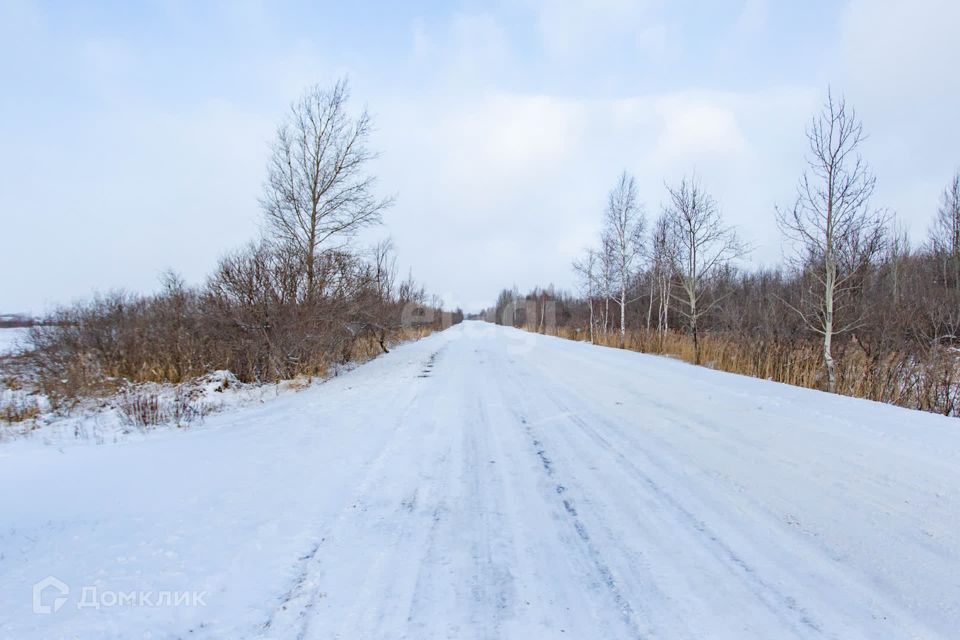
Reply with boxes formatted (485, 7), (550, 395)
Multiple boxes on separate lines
(0, 0), (960, 313)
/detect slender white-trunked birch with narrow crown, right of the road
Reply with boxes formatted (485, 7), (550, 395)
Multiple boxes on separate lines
(603, 171), (645, 349)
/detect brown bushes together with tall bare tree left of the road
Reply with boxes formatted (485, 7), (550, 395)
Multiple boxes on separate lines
(27, 81), (462, 399)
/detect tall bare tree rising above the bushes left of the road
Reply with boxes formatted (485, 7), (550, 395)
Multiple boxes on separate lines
(260, 80), (391, 299)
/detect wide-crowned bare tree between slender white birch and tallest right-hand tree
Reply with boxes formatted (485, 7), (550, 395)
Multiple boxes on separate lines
(664, 176), (745, 364)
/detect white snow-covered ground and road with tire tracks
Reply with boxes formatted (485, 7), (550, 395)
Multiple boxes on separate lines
(0, 322), (960, 640)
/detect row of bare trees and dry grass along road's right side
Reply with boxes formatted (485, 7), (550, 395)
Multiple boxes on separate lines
(487, 95), (960, 415)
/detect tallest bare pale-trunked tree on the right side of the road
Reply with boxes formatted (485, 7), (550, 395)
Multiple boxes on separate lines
(777, 91), (888, 391)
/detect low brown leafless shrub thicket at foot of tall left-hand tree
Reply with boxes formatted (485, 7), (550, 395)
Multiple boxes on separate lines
(24, 244), (449, 400)
